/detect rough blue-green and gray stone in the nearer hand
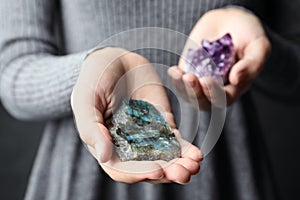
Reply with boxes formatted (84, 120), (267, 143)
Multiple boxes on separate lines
(108, 99), (180, 161)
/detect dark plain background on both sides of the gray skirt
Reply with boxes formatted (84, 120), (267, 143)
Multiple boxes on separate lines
(0, 93), (300, 200)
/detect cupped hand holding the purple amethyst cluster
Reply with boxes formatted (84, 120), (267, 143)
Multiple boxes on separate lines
(168, 8), (271, 110)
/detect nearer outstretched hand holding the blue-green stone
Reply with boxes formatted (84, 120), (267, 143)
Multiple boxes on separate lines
(71, 48), (203, 183)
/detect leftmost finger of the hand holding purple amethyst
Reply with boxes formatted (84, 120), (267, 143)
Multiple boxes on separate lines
(168, 66), (188, 101)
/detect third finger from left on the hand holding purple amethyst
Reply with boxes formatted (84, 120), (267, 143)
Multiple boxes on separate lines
(200, 77), (227, 108)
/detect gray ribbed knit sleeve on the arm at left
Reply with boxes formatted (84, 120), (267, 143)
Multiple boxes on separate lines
(0, 0), (87, 120)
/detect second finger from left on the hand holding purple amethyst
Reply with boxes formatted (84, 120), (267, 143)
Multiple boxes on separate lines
(183, 73), (210, 110)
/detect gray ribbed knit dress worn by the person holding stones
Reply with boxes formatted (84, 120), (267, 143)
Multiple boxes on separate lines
(0, 0), (300, 200)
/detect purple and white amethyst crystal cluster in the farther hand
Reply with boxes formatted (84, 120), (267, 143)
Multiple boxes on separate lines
(184, 33), (235, 82)
